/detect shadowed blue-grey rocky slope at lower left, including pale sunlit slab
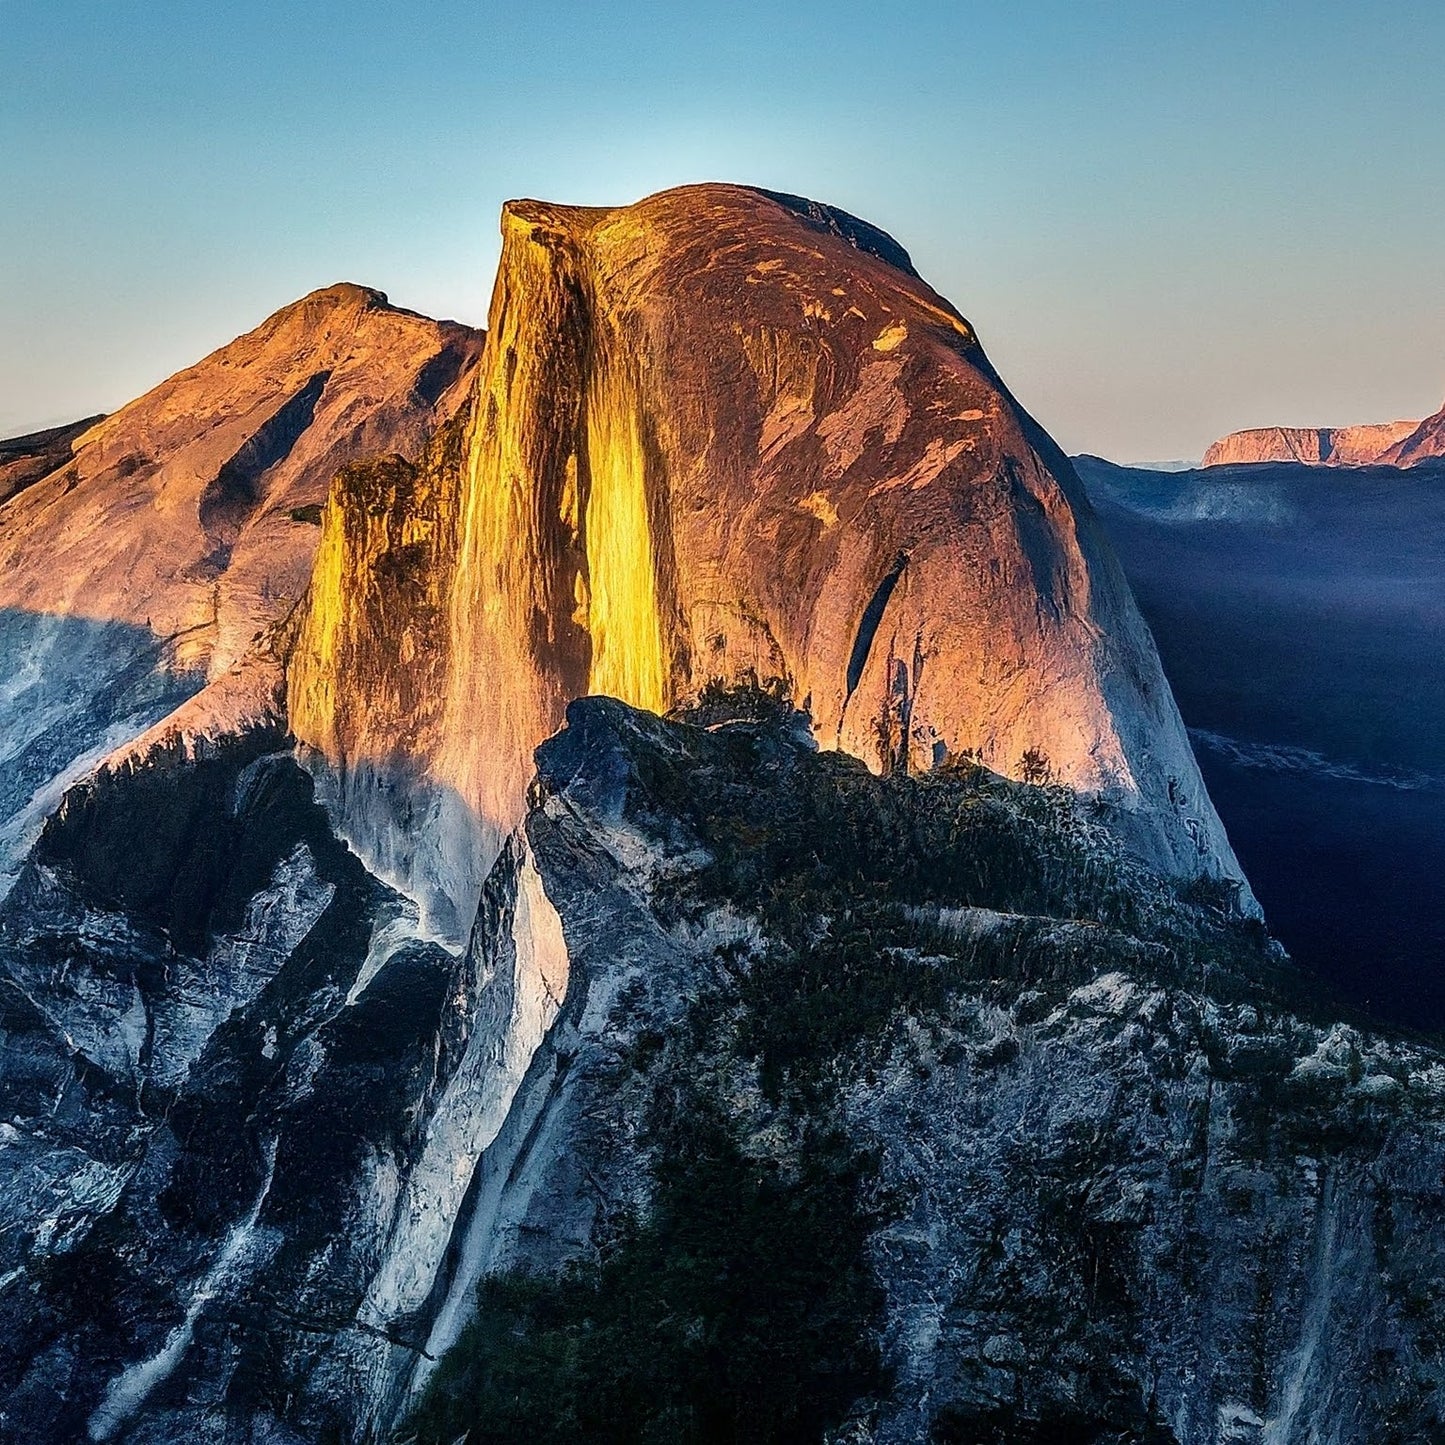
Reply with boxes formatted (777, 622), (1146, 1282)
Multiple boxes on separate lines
(0, 705), (566, 1445)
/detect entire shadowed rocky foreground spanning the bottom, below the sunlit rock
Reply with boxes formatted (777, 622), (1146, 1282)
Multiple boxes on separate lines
(0, 694), (1445, 1445)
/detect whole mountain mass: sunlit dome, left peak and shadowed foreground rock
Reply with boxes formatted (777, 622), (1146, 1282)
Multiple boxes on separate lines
(0, 185), (1445, 1445)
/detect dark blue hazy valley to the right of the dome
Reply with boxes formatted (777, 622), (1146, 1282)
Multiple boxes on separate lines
(1075, 457), (1445, 1030)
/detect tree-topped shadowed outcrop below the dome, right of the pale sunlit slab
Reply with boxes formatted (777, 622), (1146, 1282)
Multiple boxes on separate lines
(410, 699), (1445, 1445)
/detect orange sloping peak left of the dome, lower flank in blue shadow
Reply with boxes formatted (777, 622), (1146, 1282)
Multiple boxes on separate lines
(0, 285), (480, 889)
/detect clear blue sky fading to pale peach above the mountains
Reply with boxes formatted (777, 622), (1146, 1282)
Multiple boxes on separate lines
(0, 0), (1445, 460)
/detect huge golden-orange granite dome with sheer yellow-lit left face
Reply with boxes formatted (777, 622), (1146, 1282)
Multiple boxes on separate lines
(290, 186), (1237, 915)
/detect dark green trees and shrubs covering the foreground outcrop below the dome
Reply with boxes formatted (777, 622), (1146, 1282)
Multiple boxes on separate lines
(402, 696), (1300, 1445)
